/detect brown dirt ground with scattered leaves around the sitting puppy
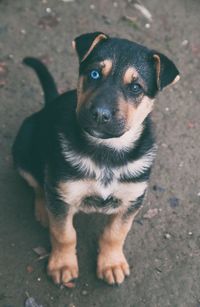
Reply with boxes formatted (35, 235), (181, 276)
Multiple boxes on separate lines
(0, 0), (200, 307)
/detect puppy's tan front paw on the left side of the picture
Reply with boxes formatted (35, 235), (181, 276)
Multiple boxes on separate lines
(47, 253), (78, 285)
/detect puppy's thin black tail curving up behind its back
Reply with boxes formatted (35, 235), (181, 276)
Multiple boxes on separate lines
(23, 57), (59, 105)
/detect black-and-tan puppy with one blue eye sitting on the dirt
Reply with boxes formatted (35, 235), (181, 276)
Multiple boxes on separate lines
(13, 32), (179, 284)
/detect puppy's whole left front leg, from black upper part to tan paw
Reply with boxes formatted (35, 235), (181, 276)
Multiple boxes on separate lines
(47, 183), (78, 284)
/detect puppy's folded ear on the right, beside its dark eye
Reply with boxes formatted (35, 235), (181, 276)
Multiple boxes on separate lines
(153, 51), (180, 91)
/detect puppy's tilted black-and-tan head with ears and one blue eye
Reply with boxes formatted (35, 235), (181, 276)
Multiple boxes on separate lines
(74, 32), (178, 139)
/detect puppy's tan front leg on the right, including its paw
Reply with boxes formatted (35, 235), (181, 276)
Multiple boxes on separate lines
(97, 206), (141, 284)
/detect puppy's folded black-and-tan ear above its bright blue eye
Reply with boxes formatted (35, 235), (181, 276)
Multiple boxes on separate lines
(72, 32), (109, 63)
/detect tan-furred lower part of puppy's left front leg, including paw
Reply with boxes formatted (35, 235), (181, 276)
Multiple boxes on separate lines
(48, 212), (78, 284)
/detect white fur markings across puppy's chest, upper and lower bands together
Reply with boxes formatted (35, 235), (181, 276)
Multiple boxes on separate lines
(58, 136), (156, 213)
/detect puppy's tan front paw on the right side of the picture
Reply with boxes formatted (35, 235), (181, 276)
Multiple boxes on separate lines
(97, 251), (130, 285)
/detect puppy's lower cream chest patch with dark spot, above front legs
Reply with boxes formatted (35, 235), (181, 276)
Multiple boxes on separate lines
(59, 169), (146, 214)
